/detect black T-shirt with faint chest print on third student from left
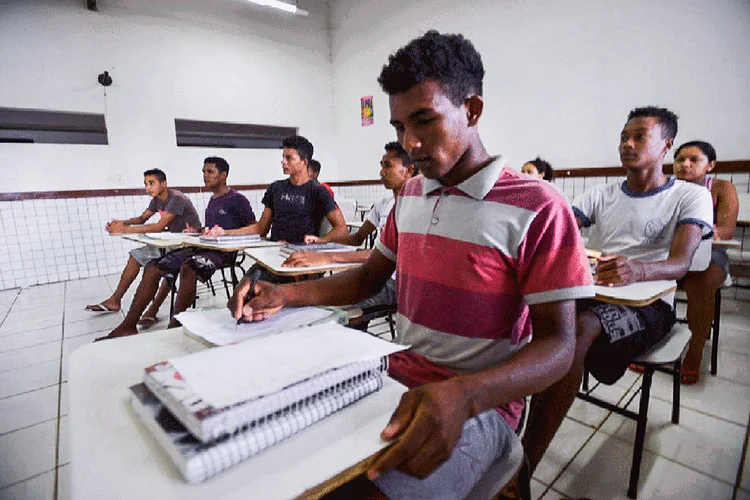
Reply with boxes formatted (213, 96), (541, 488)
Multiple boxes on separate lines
(262, 179), (337, 244)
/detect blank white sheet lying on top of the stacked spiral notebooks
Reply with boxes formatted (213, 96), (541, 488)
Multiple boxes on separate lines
(169, 323), (407, 408)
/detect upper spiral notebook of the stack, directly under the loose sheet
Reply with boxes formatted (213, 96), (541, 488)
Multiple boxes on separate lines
(143, 358), (387, 443)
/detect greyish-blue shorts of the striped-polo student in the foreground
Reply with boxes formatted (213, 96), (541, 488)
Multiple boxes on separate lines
(374, 410), (517, 500)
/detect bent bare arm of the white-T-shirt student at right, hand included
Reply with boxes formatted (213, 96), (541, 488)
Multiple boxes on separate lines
(594, 224), (701, 286)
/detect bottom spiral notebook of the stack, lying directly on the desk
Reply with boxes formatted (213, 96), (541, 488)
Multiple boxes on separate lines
(130, 374), (383, 483)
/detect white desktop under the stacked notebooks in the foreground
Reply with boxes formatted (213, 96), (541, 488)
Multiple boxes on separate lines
(67, 330), (406, 500)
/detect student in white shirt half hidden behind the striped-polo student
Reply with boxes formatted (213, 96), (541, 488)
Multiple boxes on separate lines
(284, 142), (415, 328)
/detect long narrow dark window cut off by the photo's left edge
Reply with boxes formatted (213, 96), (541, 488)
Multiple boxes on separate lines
(0, 108), (109, 144)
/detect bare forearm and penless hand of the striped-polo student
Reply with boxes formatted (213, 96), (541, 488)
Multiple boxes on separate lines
(367, 300), (576, 479)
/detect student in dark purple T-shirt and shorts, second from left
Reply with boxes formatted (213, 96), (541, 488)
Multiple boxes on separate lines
(96, 156), (255, 340)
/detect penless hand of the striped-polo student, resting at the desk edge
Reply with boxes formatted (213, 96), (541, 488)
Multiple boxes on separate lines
(367, 379), (470, 480)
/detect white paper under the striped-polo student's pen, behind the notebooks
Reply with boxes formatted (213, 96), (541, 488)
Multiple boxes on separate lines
(175, 307), (335, 346)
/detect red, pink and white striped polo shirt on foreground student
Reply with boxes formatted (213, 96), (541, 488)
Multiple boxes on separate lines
(376, 157), (594, 425)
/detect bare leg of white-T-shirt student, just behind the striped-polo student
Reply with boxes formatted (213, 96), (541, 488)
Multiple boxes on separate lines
(523, 311), (602, 473)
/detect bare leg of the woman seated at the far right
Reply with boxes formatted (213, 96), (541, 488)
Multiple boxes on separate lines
(682, 264), (724, 383)
